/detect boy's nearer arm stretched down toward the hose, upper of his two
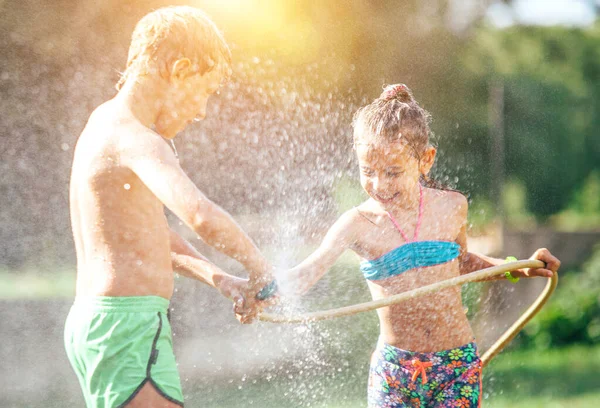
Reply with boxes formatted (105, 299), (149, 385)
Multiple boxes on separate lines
(120, 129), (271, 291)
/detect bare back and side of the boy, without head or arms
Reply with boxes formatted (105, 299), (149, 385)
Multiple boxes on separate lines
(70, 101), (173, 299)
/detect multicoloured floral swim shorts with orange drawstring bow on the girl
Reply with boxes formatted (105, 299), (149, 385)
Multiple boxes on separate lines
(368, 342), (481, 408)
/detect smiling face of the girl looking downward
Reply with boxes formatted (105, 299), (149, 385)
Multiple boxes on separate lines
(356, 142), (421, 205)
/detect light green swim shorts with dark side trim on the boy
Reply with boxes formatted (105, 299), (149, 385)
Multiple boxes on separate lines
(65, 296), (183, 408)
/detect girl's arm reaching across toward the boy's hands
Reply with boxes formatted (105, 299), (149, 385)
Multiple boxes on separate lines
(278, 210), (356, 295)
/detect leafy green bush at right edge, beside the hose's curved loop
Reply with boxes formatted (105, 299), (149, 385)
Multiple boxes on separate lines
(520, 247), (600, 348)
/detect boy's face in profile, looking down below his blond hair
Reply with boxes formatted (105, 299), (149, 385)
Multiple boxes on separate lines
(155, 69), (223, 139)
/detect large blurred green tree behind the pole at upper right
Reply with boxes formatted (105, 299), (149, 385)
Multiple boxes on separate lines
(461, 24), (600, 219)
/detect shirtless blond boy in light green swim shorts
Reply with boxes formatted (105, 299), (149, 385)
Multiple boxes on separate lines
(65, 7), (271, 408)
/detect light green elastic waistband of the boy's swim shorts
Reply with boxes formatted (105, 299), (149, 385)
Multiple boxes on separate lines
(73, 296), (169, 313)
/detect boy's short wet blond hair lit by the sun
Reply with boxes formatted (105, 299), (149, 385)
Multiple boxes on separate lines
(116, 6), (231, 90)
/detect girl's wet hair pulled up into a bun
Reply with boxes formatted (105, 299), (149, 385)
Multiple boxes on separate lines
(352, 84), (431, 158)
